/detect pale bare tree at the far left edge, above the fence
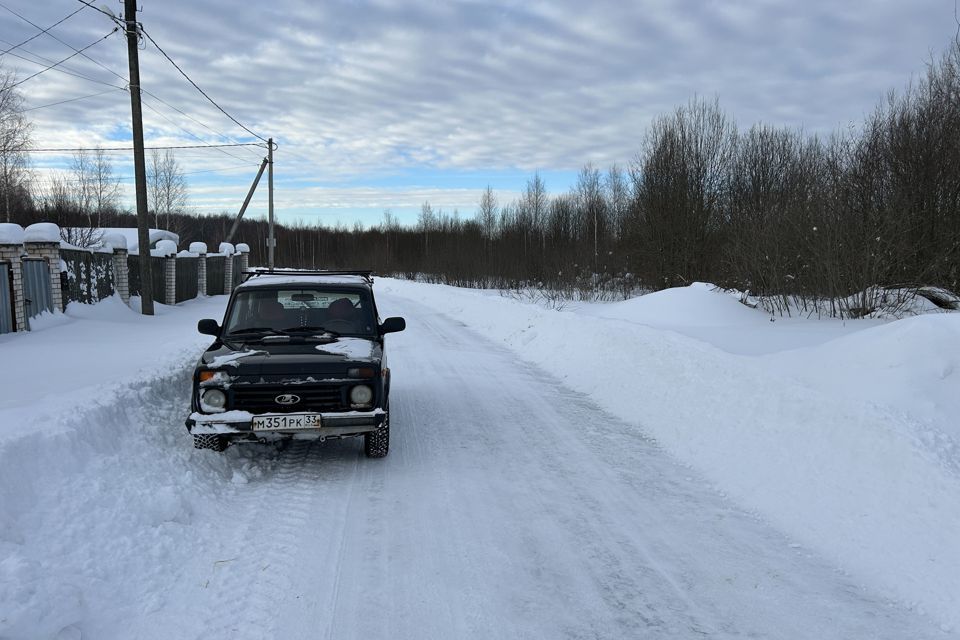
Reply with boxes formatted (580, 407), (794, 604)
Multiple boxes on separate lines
(0, 70), (31, 222)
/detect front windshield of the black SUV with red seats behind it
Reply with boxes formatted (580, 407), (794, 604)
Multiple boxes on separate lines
(224, 287), (377, 337)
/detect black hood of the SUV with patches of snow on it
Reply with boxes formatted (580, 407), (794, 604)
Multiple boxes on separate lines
(201, 337), (383, 376)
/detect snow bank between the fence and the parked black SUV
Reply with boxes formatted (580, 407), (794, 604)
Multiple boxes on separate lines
(0, 296), (237, 638)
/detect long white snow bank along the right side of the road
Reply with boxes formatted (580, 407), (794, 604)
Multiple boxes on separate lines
(378, 280), (960, 628)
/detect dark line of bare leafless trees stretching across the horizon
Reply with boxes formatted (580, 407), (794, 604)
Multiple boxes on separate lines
(0, 42), (960, 316)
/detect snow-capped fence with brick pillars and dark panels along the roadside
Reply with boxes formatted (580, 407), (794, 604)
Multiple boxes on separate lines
(0, 223), (250, 333)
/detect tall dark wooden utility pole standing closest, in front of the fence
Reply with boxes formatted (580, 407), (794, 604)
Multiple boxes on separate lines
(123, 0), (153, 316)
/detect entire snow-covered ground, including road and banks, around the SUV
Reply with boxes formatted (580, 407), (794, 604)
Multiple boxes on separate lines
(0, 280), (960, 638)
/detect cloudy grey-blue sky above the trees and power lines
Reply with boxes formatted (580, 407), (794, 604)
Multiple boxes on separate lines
(0, 0), (957, 225)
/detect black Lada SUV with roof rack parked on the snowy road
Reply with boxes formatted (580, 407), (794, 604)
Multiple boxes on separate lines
(186, 270), (406, 458)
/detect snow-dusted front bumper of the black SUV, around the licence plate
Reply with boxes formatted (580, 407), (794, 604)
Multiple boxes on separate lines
(186, 409), (387, 442)
